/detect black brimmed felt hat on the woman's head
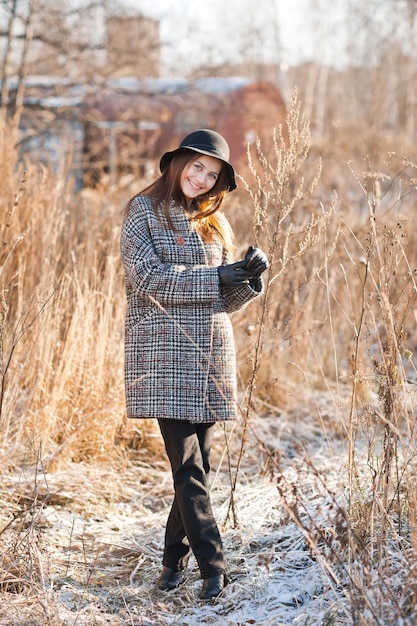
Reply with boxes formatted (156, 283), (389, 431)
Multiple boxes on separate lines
(159, 128), (237, 191)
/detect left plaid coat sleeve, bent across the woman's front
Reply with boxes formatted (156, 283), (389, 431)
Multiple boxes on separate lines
(120, 194), (221, 305)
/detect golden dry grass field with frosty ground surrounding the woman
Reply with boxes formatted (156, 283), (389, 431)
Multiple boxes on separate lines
(0, 95), (417, 626)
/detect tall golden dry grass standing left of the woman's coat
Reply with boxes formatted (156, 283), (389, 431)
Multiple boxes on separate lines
(0, 111), (154, 464)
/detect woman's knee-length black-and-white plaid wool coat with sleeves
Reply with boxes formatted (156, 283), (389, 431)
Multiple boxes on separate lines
(121, 196), (262, 422)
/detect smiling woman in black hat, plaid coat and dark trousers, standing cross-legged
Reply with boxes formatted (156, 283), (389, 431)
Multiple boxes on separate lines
(121, 129), (268, 600)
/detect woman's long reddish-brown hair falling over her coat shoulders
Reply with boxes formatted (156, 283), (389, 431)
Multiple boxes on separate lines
(126, 149), (233, 252)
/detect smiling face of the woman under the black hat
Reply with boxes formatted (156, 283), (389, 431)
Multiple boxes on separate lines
(181, 154), (222, 200)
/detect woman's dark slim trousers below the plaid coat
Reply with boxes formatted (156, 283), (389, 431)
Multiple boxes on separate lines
(158, 419), (227, 578)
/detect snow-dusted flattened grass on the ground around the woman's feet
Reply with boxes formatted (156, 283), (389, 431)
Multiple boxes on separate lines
(0, 408), (349, 626)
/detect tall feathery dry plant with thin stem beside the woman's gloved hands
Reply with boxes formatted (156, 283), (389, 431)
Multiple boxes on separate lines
(224, 91), (335, 526)
